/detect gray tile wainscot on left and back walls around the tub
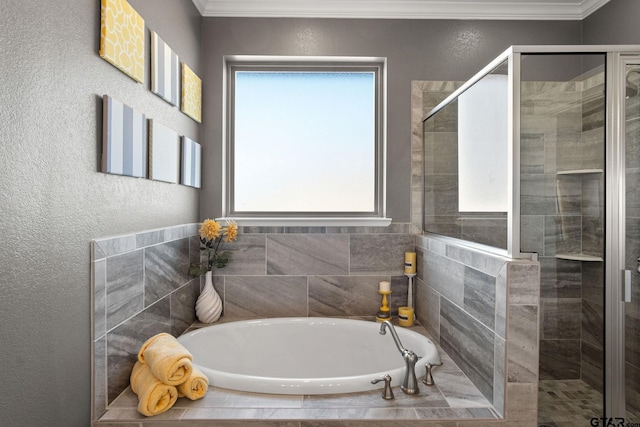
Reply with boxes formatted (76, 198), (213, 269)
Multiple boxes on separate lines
(92, 224), (414, 418)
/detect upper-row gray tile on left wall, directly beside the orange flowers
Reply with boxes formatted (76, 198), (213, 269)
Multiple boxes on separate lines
(144, 239), (189, 306)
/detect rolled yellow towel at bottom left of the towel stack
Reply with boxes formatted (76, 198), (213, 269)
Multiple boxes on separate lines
(130, 362), (178, 417)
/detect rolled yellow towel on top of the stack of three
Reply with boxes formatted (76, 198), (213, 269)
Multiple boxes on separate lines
(138, 332), (193, 385)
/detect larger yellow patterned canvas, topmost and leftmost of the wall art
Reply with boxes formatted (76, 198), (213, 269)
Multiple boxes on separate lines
(100, 0), (144, 83)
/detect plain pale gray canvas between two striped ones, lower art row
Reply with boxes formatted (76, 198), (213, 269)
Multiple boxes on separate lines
(149, 119), (180, 184)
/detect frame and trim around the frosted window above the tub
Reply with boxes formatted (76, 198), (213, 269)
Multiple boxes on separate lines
(222, 55), (391, 225)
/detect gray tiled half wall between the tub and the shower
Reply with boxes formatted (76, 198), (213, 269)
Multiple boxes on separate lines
(416, 235), (540, 422)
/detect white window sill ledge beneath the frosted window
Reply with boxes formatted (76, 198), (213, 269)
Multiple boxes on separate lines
(216, 217), (392, 227)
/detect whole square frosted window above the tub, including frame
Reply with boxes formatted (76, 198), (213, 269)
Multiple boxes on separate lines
(225, 57), (384, 227)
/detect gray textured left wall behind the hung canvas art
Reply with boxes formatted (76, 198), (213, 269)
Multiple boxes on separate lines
(0, 0), (201, 426)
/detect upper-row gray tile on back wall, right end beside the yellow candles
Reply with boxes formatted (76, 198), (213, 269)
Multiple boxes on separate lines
(349, 234), (415, 275)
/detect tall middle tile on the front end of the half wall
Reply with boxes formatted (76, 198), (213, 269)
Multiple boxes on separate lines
(507, 305), (538, 383)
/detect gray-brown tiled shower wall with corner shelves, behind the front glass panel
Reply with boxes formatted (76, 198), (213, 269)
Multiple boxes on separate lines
(521, 74), (604, 389)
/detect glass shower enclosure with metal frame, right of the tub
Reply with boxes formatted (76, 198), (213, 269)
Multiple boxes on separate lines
(423, 45), (640, 425)
